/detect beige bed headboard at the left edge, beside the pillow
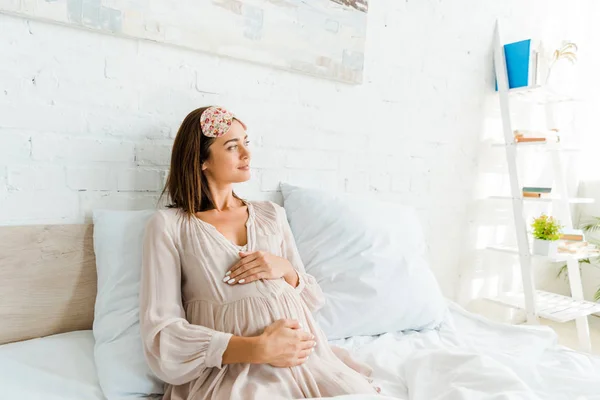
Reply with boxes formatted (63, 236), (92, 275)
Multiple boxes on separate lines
(0, 225), (96, 344)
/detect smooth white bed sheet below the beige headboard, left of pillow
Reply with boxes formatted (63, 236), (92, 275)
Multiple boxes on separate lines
(0, 330), (105, 400)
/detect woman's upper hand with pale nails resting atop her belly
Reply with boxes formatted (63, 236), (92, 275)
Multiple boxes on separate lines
(223, 251), (299, 287)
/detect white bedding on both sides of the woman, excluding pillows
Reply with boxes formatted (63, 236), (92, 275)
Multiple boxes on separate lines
(0, 304), (600, 400)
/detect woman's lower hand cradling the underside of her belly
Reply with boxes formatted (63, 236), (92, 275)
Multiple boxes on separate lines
(258, 319), (317, 368)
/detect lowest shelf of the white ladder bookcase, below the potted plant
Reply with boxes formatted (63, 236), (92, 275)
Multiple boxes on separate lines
(489, 290), (600, 322)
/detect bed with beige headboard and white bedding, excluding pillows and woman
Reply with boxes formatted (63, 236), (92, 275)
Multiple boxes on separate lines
(0, 225), (600, 400)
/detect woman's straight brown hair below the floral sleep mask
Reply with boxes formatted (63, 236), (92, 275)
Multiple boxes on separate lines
(159, 107), (242, 217)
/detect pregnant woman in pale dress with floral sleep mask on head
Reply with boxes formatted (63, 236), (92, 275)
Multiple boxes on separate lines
(140, 107), (377, 400)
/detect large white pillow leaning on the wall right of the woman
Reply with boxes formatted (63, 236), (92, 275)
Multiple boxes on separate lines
(281, 183), (447, 339)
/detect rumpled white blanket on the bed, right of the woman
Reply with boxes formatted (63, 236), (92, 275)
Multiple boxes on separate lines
(324, 304), (600, 400)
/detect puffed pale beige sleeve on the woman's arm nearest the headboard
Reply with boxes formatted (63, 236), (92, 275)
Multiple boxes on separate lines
(140, 211), (233, 385)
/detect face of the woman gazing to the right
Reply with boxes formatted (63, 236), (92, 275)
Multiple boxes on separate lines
(202, 120), (251, 184)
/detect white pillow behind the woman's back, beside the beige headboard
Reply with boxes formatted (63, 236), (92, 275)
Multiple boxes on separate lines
(93, 210), (163, 400)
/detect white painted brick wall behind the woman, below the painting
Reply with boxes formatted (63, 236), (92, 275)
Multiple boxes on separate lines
(0, 0), (588, 296)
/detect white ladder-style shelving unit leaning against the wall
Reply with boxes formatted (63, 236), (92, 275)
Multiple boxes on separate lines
(488, 21), (600, 351)
